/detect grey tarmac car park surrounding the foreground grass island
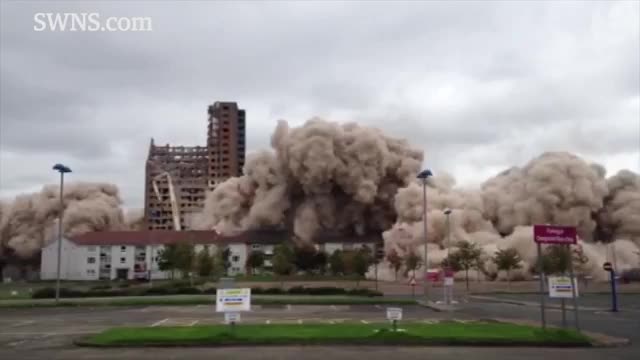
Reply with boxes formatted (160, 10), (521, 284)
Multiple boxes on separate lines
(0, 295), (640, 360)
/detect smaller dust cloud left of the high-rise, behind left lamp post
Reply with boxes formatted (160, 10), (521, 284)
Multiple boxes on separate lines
(0, 182), (142, 260)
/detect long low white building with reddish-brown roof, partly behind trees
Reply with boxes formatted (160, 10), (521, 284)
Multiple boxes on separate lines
(40, 230), (382, 280)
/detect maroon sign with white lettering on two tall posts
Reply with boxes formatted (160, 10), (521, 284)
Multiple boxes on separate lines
(533, 225), (580, 331)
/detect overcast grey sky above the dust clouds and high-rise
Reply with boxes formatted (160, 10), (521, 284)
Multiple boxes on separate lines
(0, 0), (640, 208)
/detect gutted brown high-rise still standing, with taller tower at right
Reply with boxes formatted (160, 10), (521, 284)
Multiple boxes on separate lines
(144, 102), (246, 230)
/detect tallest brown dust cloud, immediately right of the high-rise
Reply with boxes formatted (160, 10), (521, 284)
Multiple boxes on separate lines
(194, 119), (422, 242)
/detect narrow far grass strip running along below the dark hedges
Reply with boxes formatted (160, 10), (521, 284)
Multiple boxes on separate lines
(0, 295), (416, 308)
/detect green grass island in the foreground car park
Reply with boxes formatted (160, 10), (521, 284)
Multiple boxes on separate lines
(78, 322), (590, 346)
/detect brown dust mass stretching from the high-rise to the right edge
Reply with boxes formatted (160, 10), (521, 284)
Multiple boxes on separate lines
(194, 118), (640, 278)
